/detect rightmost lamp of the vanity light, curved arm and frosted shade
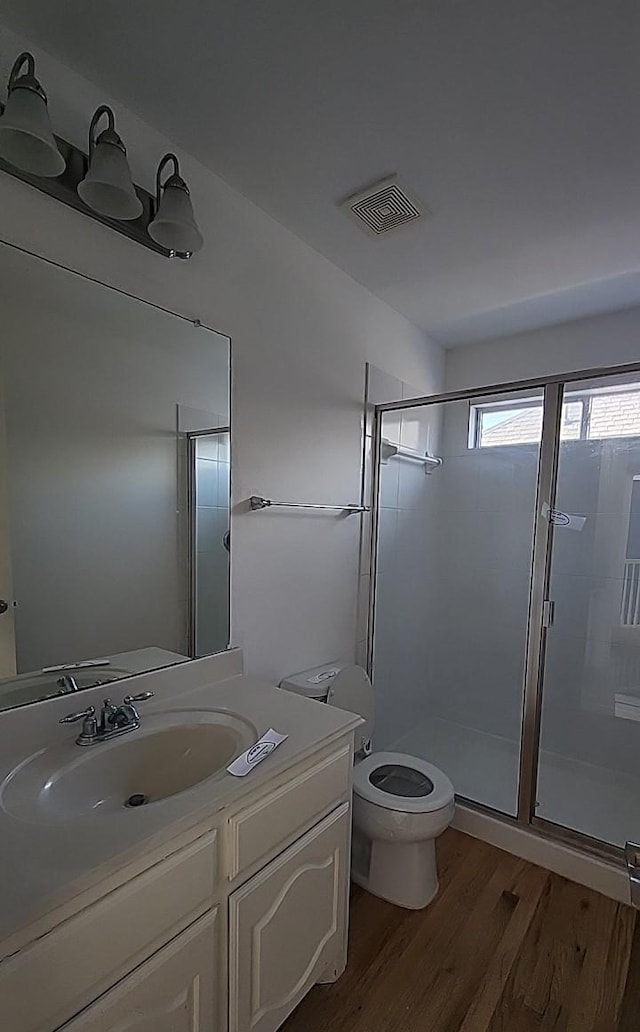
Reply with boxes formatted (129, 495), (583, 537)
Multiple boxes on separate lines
(149, 154), (204, 258)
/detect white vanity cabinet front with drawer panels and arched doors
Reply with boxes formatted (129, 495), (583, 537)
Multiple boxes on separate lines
(0, 734), (353, 1032)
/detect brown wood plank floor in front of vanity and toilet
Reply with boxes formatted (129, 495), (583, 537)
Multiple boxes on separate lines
(285, 829), (640, 1032)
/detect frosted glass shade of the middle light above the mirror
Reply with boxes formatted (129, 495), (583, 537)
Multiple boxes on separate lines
(77, 138), (142, 222)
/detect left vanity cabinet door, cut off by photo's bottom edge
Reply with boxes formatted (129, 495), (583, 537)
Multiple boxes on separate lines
(60, 911), (218, 1032)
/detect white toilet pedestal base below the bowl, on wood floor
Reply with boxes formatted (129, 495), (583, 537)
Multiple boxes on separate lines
(351, 839), (438, 910)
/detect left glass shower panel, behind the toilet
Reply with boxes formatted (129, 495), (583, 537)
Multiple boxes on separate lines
(373, 389), (543, 815)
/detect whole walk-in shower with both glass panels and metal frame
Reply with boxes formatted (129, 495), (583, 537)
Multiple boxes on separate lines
(370, 366), (640, 851)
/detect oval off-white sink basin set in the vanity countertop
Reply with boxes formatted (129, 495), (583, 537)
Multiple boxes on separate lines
(0, 710), (258, 824)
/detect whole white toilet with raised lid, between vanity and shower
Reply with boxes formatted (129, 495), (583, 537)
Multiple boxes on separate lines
(280, 663), (455, 910)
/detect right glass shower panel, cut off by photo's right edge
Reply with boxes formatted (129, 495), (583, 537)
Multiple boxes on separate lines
(536, 374), (640, 846)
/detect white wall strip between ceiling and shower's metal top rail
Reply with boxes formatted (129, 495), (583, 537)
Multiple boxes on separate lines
(445, 308), (640, 390)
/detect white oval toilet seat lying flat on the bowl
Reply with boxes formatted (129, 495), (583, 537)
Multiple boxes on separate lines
(353, 752), (454, 813)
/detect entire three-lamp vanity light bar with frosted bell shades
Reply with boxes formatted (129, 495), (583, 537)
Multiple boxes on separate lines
(0, 52), (203, 258)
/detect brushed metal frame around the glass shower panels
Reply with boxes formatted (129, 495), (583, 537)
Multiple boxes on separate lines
(366, 362), (640, 864)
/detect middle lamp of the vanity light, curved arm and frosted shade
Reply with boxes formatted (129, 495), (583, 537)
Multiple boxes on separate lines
(77, 104), (142, 221)
